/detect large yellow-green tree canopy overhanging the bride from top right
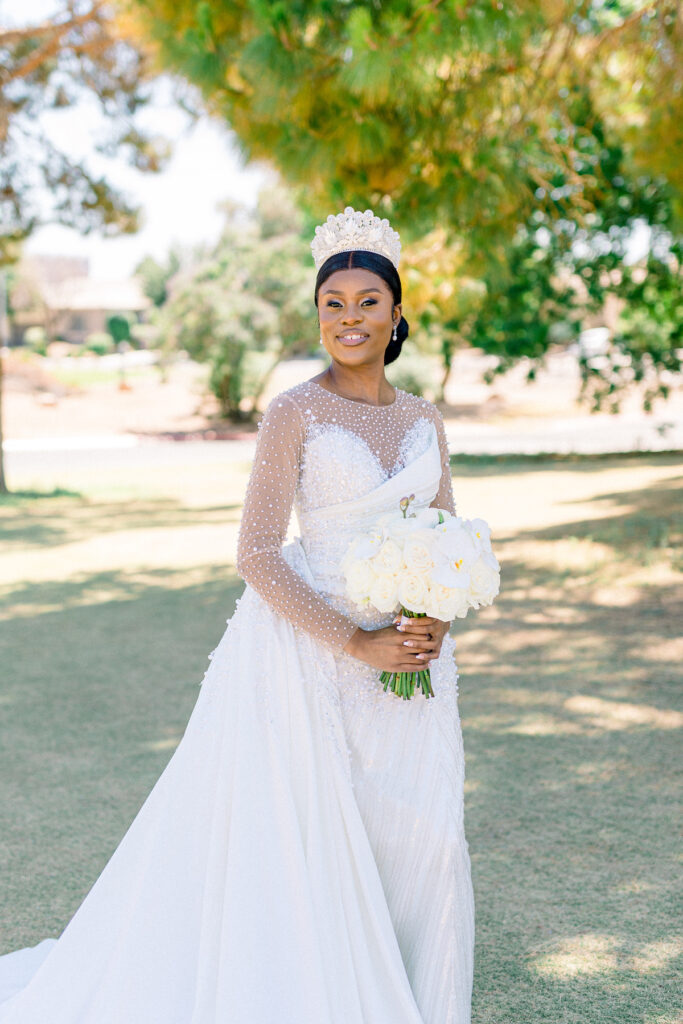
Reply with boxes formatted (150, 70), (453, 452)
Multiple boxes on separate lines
(128, 0), (683, 411)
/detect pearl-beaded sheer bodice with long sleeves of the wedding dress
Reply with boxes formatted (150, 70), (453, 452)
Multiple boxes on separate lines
(237, 381), (455, 652)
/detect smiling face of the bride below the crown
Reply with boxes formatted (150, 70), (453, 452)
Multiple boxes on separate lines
(317, 267), (400, 367)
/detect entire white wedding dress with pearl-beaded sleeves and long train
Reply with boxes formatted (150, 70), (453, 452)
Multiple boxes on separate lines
(0, 381), (474, 1024)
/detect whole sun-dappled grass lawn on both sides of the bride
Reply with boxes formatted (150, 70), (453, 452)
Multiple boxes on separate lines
(0, 456), (683, 1024)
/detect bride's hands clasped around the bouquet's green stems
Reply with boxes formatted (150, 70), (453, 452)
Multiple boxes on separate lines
(344, 615), (451, 672)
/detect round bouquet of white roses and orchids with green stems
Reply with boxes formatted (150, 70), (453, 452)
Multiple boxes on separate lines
(341, 495), (501, 700)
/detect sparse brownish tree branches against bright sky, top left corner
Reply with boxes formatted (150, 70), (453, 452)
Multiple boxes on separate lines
(0, 0), (176, 264)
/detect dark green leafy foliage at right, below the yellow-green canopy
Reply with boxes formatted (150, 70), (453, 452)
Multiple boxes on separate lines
(456, 86), (683, 412)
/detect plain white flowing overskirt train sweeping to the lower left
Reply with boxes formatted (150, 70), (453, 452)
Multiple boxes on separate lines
(0, 548), (432, 1024)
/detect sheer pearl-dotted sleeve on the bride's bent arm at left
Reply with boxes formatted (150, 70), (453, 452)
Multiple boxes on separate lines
(237, 395), (356, 652)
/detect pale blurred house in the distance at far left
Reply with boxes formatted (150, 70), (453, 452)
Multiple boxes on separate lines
(11, 256), (152, 345)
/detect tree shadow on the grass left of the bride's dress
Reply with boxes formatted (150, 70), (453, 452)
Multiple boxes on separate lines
(0, 568), (244, 949)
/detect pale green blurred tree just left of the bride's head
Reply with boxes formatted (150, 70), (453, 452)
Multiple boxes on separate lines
(155, 188), (314, 420)
